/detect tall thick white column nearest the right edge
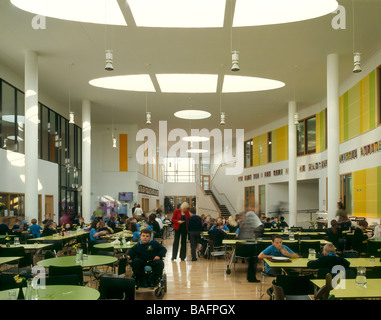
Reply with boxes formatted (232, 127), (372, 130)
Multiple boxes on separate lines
(327, 54), (340, 225)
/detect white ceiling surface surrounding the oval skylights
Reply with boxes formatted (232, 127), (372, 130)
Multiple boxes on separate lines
(0, 0), (381, 134)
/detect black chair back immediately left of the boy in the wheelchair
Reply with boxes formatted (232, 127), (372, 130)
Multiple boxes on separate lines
(98, 274), (135, 300)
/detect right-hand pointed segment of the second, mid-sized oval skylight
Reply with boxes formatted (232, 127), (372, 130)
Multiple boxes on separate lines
(222, 75), (285, 93)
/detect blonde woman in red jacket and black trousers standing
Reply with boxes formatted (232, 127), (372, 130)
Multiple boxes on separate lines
(171, 202), (190, 261)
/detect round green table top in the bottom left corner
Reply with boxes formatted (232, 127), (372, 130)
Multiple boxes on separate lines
(0, 286), (100, 300)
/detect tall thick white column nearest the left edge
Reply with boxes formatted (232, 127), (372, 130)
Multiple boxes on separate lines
(24, 51), (38, 222)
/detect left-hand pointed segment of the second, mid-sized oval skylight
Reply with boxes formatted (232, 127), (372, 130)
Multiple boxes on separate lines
(89, 74), (156, 92)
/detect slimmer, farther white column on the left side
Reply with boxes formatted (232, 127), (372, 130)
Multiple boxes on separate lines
(82, 100), (94, 222)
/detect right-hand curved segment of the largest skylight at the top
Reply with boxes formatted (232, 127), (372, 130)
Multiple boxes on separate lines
(233, 0), (338, 27)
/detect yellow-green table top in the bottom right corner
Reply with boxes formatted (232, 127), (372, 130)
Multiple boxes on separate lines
(311, 279), (381, 299)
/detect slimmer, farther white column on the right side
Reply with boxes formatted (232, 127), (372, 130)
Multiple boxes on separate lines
(288, 101), (298, 226)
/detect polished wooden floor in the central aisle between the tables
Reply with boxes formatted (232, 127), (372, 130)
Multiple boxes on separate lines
(117, 237), (273, 300)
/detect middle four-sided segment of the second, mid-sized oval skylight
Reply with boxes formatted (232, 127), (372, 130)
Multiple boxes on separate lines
(156, 73), (218, 93)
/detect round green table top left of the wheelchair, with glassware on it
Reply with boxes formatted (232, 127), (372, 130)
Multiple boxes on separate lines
(37, 255), (117, 268)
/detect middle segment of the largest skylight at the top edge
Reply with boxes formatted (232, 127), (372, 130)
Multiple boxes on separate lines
(127, 0), (226, 28)
